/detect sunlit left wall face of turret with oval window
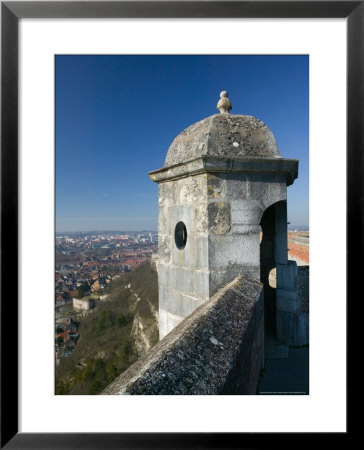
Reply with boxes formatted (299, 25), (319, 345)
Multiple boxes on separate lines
(158, 174), (210, 338)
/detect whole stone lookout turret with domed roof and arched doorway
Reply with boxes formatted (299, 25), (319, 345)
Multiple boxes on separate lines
(150, 91), (298, 341)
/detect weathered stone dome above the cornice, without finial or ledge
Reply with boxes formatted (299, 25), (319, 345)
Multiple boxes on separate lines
(164, 113), (281, 167)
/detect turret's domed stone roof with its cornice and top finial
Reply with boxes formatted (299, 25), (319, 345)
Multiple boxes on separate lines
(149, 91), (298, 186)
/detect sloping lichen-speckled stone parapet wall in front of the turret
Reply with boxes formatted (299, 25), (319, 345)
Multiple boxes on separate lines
(103, 276), (264, 395)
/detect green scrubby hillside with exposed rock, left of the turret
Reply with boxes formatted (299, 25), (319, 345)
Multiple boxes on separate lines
(56, 264), (159, 395)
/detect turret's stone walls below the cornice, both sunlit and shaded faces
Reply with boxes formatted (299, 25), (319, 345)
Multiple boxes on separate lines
(158, 169), (287, 338)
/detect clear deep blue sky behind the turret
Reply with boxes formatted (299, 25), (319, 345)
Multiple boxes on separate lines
(55, 55), (309, 232)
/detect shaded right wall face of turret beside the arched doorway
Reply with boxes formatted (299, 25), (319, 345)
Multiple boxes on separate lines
(207, 173), (286, 295)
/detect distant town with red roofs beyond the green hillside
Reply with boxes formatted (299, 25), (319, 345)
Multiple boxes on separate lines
(55, 231), (158, 362)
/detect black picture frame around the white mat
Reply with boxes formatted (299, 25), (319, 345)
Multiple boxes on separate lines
(0, 0), (356, 449)
